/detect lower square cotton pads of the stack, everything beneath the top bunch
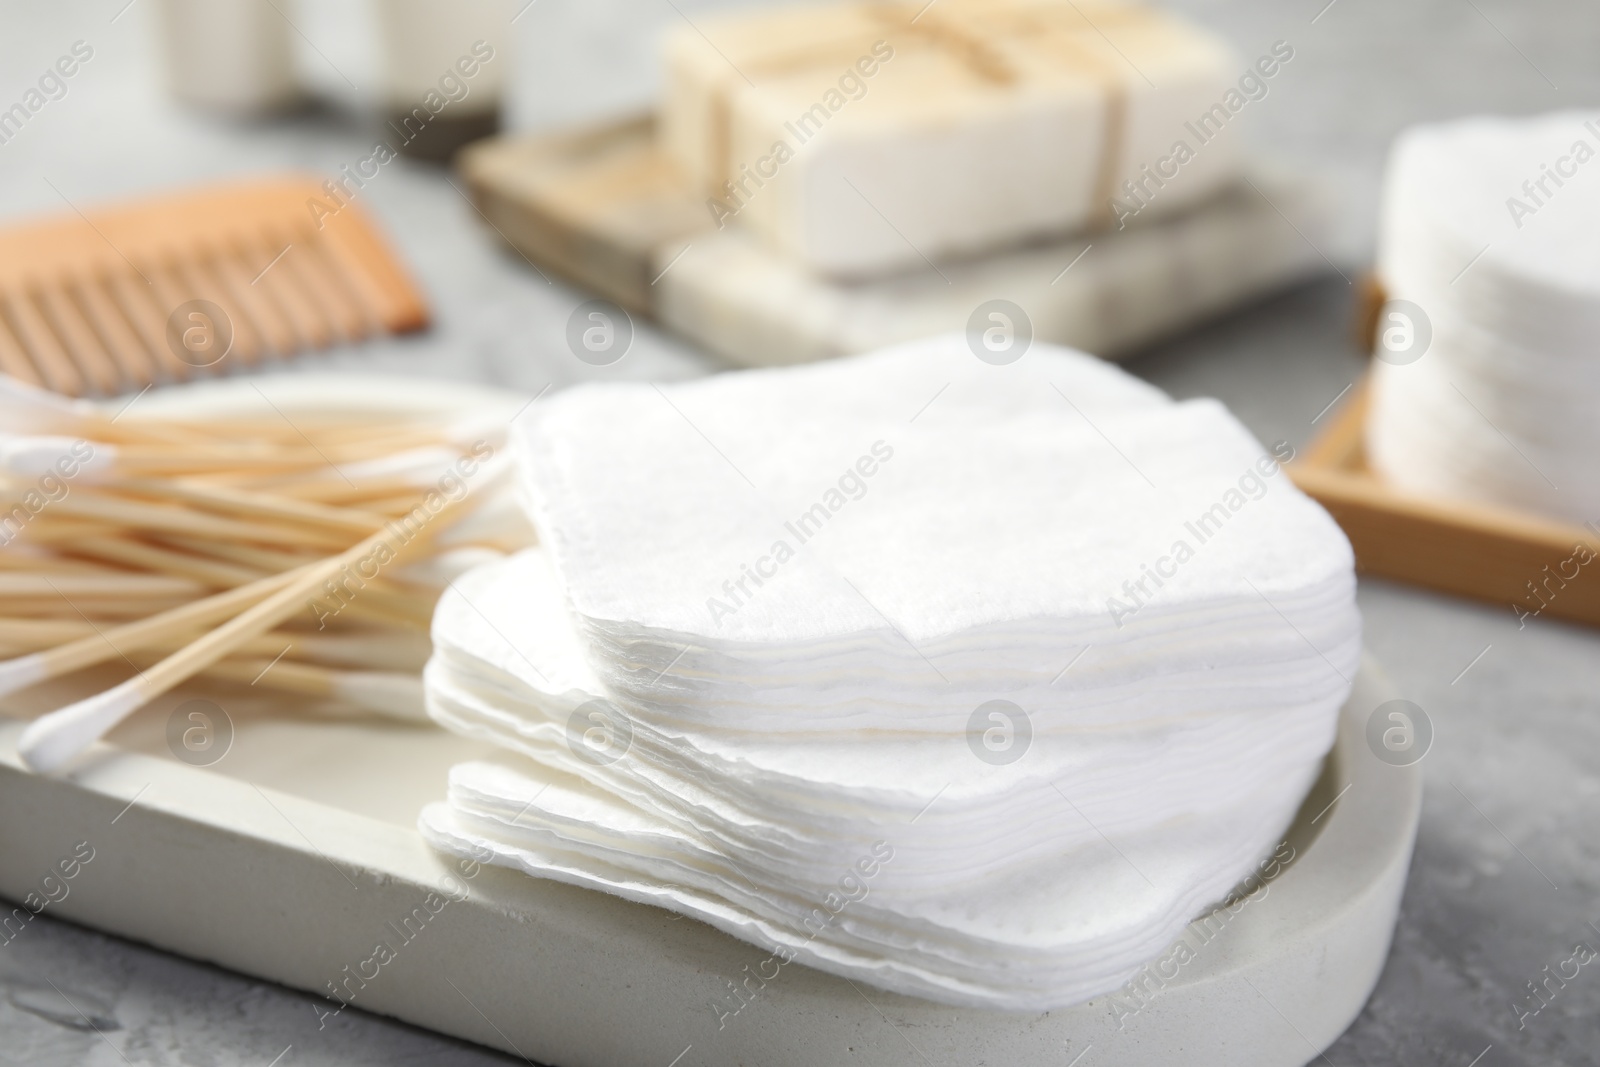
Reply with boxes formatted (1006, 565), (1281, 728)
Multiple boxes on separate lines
(422, 550), (1331, 1009)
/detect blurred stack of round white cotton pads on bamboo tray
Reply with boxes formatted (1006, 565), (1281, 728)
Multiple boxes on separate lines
(1366, 112), (1600, 522)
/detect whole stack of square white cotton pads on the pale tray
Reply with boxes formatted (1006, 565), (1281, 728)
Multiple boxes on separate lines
(422, 336), (1360, 1009)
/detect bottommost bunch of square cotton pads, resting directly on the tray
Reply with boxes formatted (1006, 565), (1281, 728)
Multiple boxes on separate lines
(421, 765), (1309, 1011)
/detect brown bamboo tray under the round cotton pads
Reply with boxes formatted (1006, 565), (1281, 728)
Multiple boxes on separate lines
(1288, 382), (1600, 625)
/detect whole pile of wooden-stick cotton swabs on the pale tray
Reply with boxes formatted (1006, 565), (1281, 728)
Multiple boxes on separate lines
(0, 378), (526, 771)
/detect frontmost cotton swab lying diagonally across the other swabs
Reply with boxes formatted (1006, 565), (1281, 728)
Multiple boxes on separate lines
(18, 496), (466, 773)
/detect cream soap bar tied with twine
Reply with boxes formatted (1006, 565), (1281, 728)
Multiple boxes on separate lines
(662, 0), (1242, 277)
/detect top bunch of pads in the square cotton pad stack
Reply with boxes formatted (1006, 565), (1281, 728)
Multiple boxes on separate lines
(518, 341), (1355, 729)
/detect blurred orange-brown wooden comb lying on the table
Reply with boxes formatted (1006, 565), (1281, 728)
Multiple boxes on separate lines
(0, 176), (427, 397)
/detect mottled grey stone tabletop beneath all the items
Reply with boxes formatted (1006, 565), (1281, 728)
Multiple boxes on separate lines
(0, 0), (1600, 1067)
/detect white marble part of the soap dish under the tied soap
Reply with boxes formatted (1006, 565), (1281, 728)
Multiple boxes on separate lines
(653, 171), (1333, 366)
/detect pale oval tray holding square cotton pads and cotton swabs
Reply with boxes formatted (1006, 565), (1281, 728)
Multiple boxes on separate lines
(0, 664), (1421, 1067)
